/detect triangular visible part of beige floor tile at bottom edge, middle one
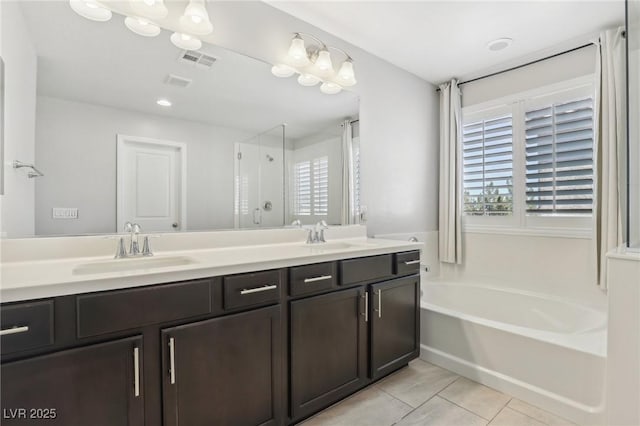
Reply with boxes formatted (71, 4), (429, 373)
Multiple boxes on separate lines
(396, 396), (487, 426)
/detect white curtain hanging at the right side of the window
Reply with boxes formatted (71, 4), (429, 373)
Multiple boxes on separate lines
(593, 28), (626, 289)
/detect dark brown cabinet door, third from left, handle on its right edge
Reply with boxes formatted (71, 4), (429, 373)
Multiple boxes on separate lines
(290, 287), (367, 420)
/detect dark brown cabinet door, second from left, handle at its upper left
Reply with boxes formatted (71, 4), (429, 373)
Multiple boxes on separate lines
(162, 306), (282, 426)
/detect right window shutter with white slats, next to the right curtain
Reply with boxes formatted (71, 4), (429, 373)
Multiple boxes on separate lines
(525, 97), (593, 214)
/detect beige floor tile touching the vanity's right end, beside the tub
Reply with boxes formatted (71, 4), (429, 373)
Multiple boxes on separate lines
(376, 359), (458, 408)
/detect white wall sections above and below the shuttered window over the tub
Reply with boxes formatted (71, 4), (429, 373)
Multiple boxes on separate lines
(433, 47), (606, 307)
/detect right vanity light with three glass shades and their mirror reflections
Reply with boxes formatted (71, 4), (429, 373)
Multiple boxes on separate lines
(271, 33), (357, 95)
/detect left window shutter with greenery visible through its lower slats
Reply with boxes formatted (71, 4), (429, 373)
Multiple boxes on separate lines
(462, 114), (513, 216)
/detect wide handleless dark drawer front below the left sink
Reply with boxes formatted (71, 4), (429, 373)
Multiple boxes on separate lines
(76, 280), (212, 337)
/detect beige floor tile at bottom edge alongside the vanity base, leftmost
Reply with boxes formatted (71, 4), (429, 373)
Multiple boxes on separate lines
(302, 387), (412, 426)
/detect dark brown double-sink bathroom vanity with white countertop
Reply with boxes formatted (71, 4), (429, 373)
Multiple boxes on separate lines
(0, 231), (420, 426)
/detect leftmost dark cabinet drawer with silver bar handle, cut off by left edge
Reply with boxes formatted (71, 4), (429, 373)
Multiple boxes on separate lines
(0, 300), (53, 354)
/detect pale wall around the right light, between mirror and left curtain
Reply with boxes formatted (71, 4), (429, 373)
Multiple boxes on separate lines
(204, 2), (439, 235)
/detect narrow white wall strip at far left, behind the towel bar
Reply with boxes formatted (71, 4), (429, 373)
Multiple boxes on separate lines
(0, 2), (38, 237)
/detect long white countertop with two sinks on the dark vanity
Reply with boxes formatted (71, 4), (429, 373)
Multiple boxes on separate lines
(0, 237), (423, 303)
